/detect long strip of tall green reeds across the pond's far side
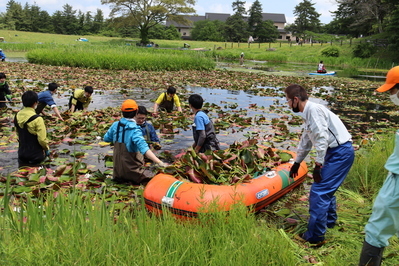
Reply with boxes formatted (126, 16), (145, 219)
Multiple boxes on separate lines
(27, 47), (215, 71)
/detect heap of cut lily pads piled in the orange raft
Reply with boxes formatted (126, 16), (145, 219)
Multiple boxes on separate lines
(164, 139), (292, 185)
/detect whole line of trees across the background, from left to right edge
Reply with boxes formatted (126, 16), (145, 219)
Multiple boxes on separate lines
(0, 0), (399, 56)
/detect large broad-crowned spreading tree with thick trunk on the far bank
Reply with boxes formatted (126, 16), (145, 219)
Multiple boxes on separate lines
(101, 0), (195, 43)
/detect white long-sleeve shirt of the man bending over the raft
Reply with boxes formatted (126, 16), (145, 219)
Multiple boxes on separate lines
(295, 101), (352, 164)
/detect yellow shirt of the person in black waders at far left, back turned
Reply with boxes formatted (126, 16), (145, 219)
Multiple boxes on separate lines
(17, 107), (50, 151)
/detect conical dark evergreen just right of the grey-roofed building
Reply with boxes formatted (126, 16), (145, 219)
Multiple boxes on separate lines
(289, 0), (321, 35)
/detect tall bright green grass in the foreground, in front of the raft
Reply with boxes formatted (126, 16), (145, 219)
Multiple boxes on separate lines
(0, 188), (299, 265)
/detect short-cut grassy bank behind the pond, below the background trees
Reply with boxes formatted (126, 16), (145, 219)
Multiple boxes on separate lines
(0, 30), (398, 70)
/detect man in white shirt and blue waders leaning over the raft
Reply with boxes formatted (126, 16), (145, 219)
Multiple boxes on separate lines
(285, 84), (355, 245)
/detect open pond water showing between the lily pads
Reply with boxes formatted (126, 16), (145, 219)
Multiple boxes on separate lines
(0, 87), (326, 174)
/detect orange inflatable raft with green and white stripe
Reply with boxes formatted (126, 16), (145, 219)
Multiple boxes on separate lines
(144, 151), (308, 218)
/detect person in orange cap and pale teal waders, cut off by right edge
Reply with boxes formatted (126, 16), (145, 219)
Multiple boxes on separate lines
(359, 66), (399, 266)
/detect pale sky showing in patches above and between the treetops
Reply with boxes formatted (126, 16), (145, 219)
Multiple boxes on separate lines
(0, 0), (337, 24)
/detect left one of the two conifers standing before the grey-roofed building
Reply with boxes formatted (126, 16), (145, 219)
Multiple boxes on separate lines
(224, 0), (249, 42)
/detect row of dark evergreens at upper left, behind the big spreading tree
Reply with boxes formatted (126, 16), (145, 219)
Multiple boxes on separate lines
(0, 0), (180, 39)
